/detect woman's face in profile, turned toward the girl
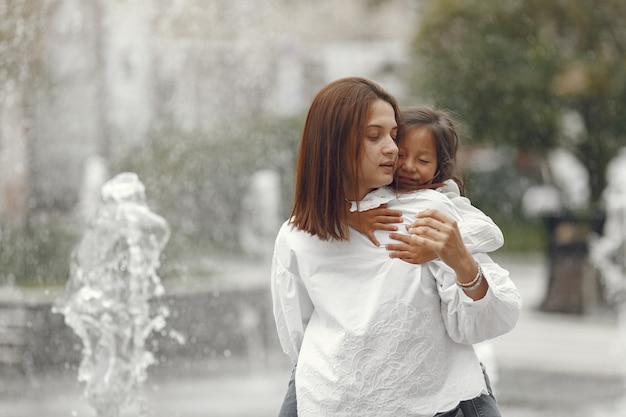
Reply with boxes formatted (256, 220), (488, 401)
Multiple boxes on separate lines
(354, 100), (398, 200)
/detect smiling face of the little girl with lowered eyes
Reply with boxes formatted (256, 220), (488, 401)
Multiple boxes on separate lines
(396, 126), (438, 191)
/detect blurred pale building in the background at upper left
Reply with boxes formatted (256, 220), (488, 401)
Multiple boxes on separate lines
(0, 0), (419, 222)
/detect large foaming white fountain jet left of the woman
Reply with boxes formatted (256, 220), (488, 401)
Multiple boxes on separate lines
(53, 173), (170, 417)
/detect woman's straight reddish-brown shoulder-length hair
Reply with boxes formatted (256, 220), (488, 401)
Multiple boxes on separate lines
(290, 77), (401, 240)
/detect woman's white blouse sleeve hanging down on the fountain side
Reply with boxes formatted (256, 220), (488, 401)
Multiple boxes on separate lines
(271, 231), (313, 365)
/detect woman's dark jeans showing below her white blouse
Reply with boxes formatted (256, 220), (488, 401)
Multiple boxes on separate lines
(278, 360), (501, 417)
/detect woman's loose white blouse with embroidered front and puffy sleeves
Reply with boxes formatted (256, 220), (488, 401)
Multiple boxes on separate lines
(271, 190), (521, 417)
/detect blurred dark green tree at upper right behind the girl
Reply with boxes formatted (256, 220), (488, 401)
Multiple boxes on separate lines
(412, 0), (626, 208)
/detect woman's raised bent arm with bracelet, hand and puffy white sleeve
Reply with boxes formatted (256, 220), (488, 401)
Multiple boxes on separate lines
(387, 196), (522, 344)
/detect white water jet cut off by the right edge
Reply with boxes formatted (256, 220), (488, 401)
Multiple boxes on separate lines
(589, 148), (626, 412)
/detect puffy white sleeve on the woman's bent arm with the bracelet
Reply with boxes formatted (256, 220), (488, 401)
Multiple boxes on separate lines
(429, 250), (522, 344)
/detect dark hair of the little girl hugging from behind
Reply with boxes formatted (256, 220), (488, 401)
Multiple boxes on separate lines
(400, 106), (465, 195)
